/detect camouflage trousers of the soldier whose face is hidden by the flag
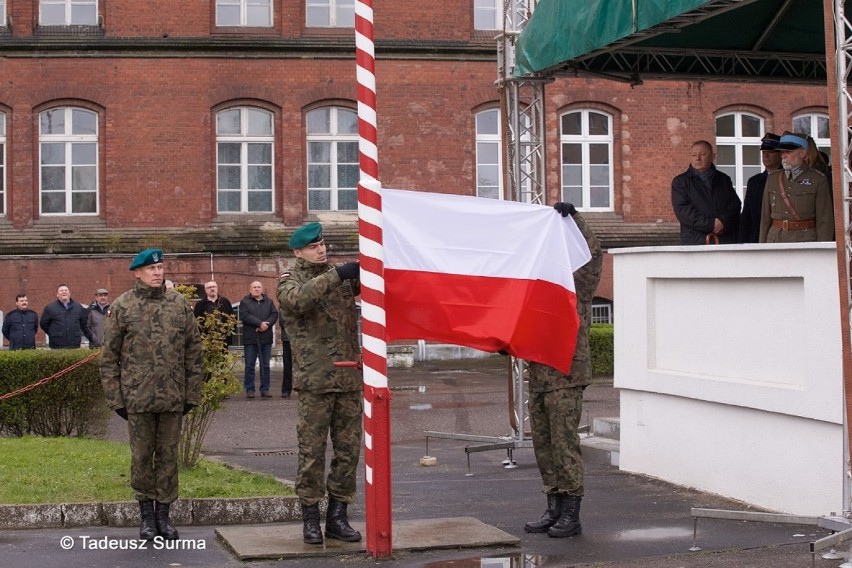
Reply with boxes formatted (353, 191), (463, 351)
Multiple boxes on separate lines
(529, 387), (583, 495)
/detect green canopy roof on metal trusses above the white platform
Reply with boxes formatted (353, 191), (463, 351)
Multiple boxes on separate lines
(514, 0), (827, 83)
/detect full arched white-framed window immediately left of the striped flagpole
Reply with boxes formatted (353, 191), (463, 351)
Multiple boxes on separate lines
(307, 107), (359, 211)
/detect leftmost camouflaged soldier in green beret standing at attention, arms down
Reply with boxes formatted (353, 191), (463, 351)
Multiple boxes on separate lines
(101, 249), (204, 540)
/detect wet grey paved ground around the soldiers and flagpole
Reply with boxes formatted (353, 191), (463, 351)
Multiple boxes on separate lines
(0, 358), (842, 568)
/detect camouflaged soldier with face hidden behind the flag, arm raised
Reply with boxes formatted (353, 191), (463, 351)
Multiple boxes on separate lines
(524, 203), (603, 537)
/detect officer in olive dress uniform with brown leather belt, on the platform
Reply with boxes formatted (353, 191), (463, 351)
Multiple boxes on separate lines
(760, 132), (834, 243)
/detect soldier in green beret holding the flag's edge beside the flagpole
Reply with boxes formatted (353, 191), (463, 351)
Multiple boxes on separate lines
(277, 223), (363, 544)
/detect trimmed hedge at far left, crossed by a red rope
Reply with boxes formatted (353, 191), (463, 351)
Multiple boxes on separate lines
(0, 349), (109, 436)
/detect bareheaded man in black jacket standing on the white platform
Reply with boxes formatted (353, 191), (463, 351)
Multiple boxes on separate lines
(672, 140), (742, 245)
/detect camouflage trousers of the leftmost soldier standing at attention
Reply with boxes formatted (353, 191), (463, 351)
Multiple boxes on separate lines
(127, 412), (183, 503)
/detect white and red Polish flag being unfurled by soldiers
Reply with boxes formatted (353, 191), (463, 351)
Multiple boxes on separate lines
(382, 189), (591, 374)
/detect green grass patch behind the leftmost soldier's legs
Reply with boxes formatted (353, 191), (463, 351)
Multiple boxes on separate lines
(0, 436), (293, 505)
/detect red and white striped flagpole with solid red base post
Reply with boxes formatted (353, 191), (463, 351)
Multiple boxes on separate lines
(355, 0), (392, 558)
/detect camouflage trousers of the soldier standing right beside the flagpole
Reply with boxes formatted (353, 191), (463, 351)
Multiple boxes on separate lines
(296, 390), (364, 505)
